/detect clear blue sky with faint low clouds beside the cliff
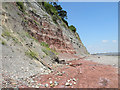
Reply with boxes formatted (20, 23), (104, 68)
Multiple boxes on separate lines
(59, 2), (118, 54)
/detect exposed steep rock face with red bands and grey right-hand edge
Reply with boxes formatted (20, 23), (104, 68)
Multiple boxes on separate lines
(25, 3), (87, 55)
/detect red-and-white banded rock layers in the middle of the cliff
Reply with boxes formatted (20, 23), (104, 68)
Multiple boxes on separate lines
(25, 8), (76, 54)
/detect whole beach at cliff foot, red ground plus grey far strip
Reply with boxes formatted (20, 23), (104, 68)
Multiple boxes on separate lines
(3, 55), (118, 88)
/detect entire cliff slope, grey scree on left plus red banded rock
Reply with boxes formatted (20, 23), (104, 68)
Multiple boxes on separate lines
(0, 2), (87, 80)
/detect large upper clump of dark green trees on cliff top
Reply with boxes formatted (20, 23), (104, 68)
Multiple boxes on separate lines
(40, 2), (68, 26)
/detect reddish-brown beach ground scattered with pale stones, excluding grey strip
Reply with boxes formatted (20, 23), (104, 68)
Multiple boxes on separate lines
(17, 56), (118, 88)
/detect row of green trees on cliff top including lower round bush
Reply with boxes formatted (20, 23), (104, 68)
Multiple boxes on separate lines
(42, 2), (76, 33)
